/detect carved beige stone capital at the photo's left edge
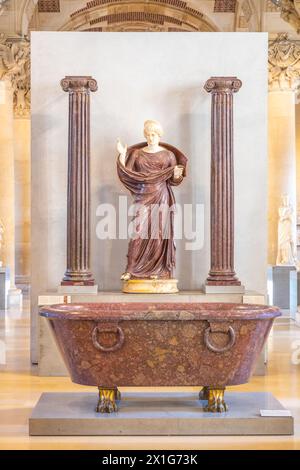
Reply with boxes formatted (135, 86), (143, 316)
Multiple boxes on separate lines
(0, 36), (30, 118)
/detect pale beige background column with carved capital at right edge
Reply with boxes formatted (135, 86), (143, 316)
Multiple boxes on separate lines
(268, 34), (300, 265)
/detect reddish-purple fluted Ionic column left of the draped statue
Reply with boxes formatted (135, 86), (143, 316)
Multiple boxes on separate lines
(61, 76), (97, 285)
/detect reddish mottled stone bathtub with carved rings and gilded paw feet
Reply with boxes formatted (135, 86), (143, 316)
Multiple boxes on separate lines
(40, 302), (281, 413)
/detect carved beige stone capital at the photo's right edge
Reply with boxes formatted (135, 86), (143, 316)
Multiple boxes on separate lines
(268, 33), (300, 91)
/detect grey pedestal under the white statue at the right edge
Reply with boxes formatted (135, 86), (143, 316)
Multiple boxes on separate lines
(268, 266), (297, 319)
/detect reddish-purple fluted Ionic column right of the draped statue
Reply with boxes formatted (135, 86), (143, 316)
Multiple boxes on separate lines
(204, 77), (242, 286)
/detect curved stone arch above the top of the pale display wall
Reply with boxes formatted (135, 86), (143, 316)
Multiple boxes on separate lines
(60, 0), (218, 32)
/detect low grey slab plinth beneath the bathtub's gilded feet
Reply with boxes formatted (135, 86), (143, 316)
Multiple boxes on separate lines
(29, 388), (294, 436)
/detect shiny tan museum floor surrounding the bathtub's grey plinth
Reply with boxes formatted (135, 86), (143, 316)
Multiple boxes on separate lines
(0, 300), (300, 449)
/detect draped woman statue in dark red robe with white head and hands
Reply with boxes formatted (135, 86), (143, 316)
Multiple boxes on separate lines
(117, 121), (187, 281)
